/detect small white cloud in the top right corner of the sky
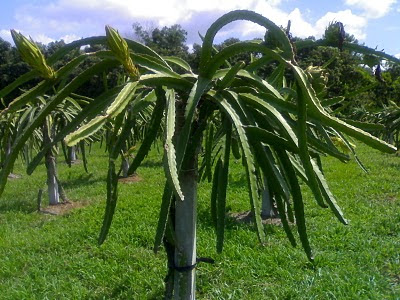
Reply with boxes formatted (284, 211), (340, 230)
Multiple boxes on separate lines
(345, 0), (397, 19)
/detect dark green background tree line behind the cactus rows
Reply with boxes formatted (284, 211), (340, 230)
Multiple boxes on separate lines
(0, 22), (400, 118)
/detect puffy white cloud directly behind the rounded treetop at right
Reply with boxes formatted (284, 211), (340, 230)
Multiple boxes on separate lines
(315, 9), (367, 40)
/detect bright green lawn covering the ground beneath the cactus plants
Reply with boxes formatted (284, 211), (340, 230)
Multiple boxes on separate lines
(0, 146), (400, 299)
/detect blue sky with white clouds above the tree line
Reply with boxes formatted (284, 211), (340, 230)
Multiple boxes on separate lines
(0, 0), (400, 57)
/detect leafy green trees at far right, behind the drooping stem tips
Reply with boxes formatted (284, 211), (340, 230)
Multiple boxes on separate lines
(294, 22), (400, 150)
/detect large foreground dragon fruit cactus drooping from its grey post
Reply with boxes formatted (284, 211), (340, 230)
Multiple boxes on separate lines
(0, 11), (396, 299)
